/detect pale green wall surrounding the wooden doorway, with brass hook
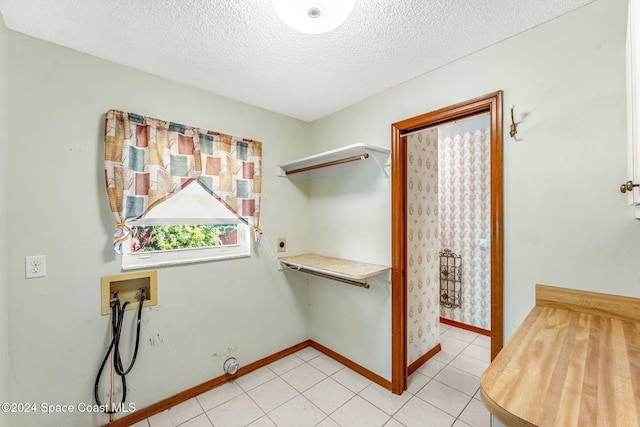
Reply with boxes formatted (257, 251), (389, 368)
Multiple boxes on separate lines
(310, 0), (640, 378)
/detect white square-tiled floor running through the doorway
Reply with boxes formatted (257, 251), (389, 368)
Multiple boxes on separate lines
(134, 325), (490, 427)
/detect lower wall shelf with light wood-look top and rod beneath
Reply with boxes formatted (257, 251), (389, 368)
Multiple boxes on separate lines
(279, 254), (391, 288)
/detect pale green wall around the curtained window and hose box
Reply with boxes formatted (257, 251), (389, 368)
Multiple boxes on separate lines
(6, 32), (309, 427)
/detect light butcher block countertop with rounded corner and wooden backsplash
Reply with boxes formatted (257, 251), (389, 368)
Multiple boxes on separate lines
(480, 285), (640, 427)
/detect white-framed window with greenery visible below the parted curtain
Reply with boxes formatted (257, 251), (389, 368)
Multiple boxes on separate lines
(122, 181), (251, 270)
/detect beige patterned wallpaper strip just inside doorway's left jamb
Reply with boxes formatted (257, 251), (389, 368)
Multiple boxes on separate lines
(407, 129), (440, 365)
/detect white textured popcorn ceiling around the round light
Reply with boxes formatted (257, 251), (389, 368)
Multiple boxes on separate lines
(0, 0), (592, 121)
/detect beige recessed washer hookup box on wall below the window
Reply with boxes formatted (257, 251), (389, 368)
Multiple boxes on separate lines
(101, 270), (158, 316)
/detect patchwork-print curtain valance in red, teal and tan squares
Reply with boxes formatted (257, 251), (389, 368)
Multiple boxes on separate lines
(104, 110), (262, 253)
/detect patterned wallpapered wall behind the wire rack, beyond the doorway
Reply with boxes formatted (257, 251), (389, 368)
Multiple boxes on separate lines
(438, 123), (491, 329)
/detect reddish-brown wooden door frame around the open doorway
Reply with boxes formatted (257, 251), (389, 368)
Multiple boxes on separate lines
(391, 91), (504, 394)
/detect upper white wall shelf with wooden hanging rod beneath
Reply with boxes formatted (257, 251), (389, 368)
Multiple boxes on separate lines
(278, 144), (390, 179)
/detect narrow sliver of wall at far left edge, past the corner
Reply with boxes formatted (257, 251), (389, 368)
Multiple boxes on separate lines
(0, 10), (11, 427)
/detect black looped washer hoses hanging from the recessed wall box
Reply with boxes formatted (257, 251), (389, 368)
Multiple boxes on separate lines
(93, 289), (146, 414)
